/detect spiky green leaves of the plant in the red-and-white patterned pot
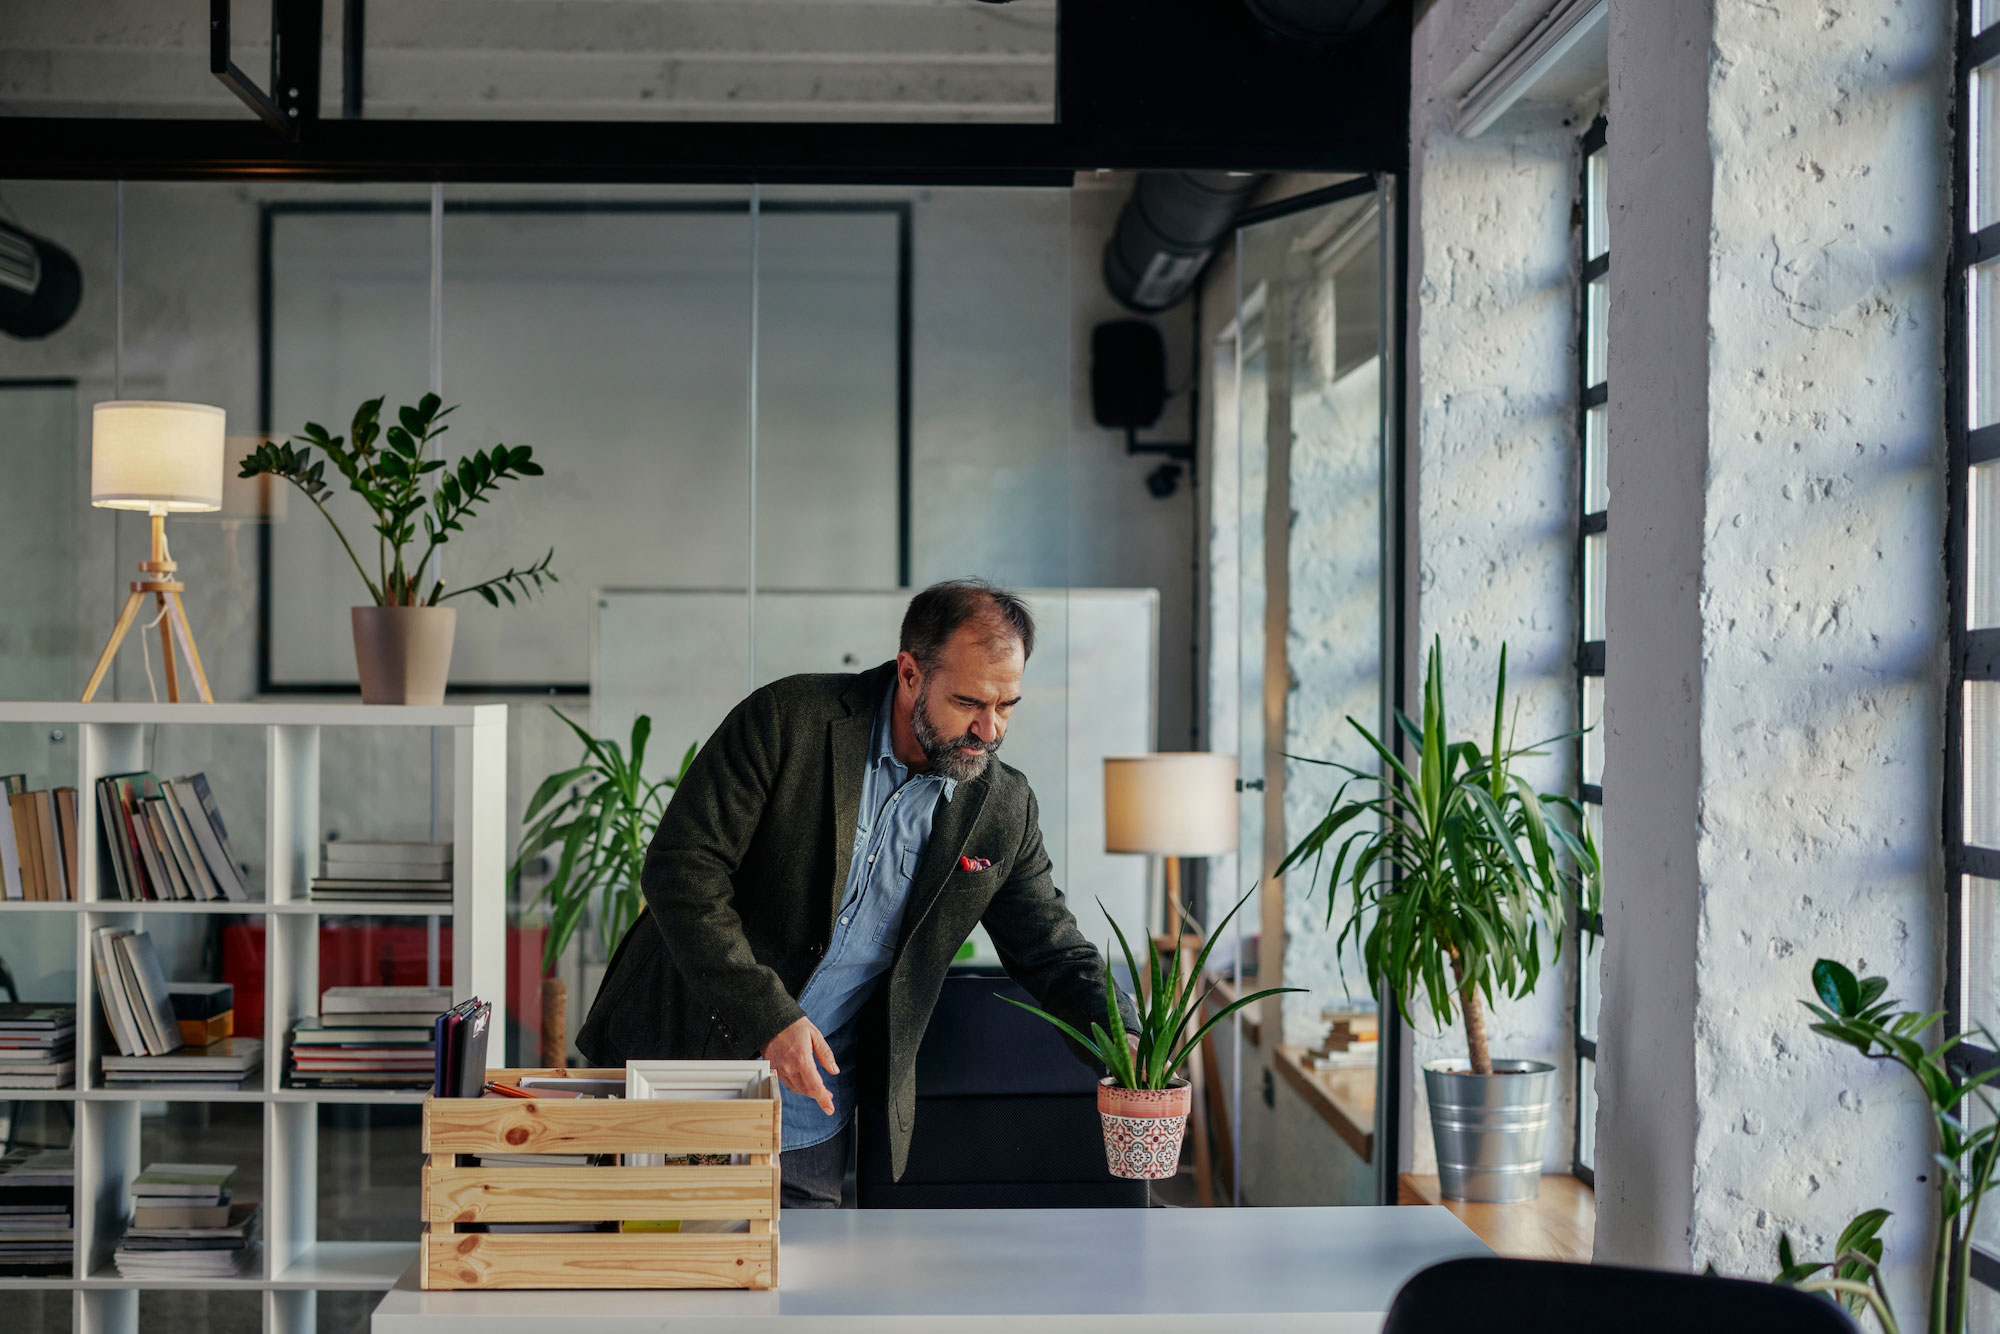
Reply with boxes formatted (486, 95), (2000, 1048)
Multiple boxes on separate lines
(1000, 890), (1306, 1088)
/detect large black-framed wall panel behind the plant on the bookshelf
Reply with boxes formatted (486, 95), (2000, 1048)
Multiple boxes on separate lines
(258, 198), (910, 694)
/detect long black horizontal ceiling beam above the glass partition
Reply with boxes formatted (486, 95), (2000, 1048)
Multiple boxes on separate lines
(0, 0), (1410, 184)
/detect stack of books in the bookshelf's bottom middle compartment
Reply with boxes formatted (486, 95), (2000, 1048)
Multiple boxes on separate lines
(112, 1162), (256, 1278)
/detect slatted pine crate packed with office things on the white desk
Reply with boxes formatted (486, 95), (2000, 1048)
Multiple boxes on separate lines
(418, 1070), (780, 1290)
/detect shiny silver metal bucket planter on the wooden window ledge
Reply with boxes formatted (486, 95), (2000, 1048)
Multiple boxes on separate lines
(1424, 1060), (1556, 1204)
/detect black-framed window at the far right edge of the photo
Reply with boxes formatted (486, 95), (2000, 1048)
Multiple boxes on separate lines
(1944, 0), (2000, 1304)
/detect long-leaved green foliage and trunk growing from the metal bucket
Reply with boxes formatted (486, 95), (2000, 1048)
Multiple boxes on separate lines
(1278, 640), (1600, 1074)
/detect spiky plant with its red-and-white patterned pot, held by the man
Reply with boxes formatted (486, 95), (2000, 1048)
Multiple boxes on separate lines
(1000, 894), (1304, 1180)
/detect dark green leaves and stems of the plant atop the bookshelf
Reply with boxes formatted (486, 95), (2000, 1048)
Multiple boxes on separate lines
(238, 394), (556, 606)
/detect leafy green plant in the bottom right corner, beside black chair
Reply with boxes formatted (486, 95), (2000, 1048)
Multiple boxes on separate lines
(1778, 958), (2000, 1334)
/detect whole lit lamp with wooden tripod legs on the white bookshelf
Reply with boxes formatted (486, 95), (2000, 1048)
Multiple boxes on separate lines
(84, 400), (224, 704)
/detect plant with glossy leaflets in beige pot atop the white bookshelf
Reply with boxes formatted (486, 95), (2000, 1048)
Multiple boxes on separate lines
(238, 394), (556, 704)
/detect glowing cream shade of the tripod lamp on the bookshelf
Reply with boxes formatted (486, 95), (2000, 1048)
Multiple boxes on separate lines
(90, 400), (224, 512)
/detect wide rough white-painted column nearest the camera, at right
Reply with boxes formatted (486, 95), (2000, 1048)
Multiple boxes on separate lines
(1596, 0), (1950, 1322)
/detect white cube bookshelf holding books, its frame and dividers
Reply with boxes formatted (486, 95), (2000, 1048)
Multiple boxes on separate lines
(0, 702), (508, 1334)
